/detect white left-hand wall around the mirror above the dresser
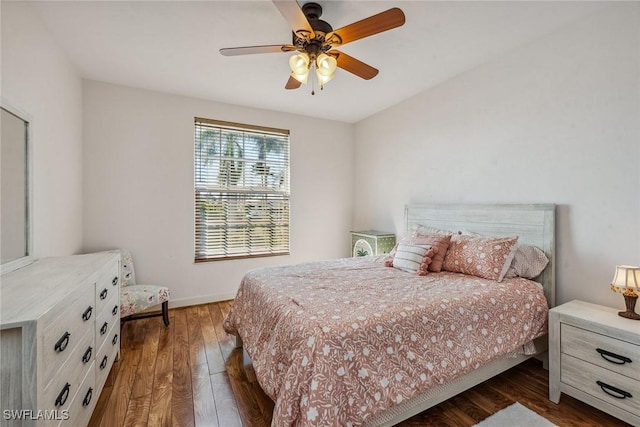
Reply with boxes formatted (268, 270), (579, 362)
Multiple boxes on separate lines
(0, 1), (82, 257)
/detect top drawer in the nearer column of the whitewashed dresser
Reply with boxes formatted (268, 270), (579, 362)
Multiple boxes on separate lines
(42, 286), (96, 384)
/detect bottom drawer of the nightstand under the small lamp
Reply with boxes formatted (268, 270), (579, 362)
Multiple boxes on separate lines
(560, 354), (640, 414)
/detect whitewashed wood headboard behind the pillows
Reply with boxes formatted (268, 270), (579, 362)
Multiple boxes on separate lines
(405, 203), (556, 307)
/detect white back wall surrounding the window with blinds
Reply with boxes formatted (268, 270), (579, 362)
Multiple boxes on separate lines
(83, 81), (353, 306)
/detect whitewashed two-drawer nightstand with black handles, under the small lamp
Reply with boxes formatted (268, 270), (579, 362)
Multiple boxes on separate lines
(549, 301), (640, 426)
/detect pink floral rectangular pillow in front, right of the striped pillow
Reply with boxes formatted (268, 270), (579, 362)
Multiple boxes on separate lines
(442, 235), (518, 282)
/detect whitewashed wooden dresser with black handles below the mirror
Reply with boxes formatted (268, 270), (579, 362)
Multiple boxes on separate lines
(0, 252), (121, 427)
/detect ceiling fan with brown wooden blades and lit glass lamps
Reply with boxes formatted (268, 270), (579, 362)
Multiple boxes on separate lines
(220, 0), (405, 94)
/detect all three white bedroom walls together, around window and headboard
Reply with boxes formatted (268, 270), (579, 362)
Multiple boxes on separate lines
(1, 2), (640, 314)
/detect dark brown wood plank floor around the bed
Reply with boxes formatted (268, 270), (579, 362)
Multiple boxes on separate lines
(89, 301), (628, 427)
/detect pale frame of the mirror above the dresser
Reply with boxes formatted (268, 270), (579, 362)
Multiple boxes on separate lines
(0, 97), (35, 275)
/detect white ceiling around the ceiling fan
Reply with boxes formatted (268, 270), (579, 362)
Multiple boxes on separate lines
(33, 0), (604, 123)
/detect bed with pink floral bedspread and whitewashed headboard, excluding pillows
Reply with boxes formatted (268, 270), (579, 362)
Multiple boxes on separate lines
(224, 204), (555, 426)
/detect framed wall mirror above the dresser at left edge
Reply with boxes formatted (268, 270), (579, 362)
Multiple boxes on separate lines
(0, 102), (32, 273)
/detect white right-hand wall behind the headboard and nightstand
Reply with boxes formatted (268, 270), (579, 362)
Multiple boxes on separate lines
(354, 2), (640, 308)
